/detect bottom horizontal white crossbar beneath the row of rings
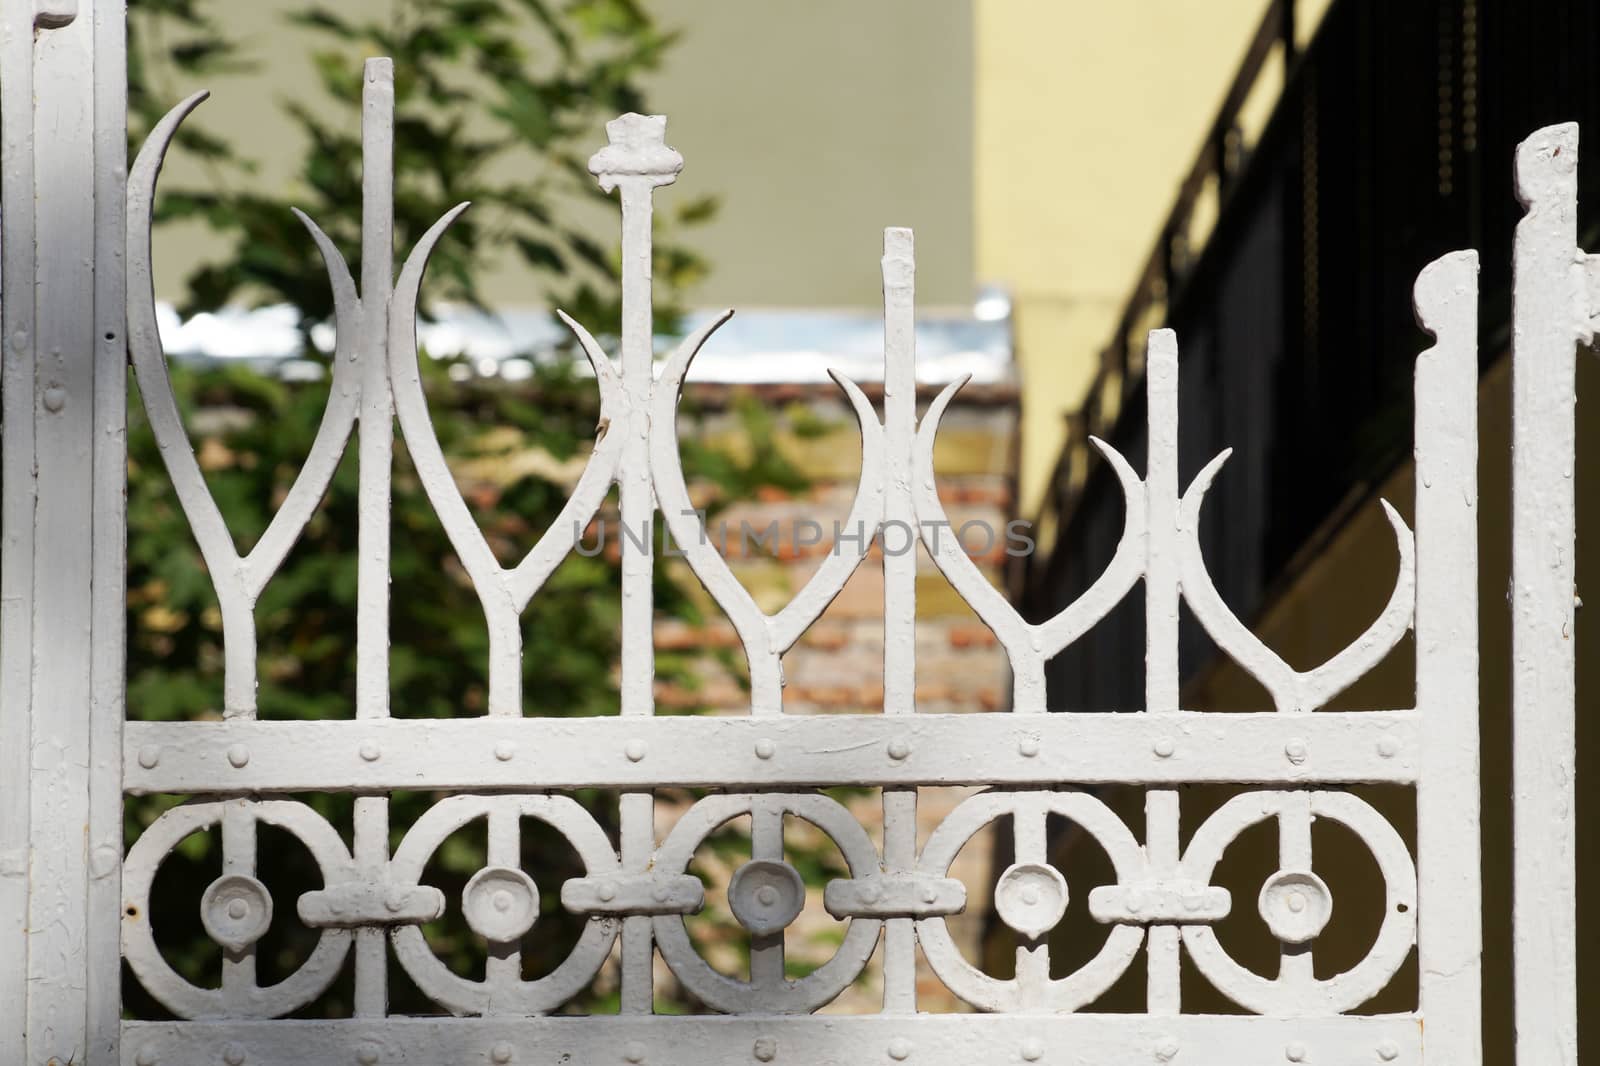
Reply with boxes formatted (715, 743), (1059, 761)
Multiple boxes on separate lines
(122, 1015), (1422, 1066)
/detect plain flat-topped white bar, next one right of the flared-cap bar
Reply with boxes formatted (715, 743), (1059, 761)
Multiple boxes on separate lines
(882, 229), (918, 1013)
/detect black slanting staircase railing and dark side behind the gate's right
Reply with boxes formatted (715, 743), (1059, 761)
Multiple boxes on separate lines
(1016, 0), (1600, 707)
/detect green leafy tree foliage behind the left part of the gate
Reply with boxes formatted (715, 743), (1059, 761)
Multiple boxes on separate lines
(126, 0), (802, 1016)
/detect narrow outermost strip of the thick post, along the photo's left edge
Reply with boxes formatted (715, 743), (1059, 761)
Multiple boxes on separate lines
(0, 3), (35, 1063)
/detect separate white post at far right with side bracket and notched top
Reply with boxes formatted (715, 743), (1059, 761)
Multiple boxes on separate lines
(1510, 123), (1589, 1066)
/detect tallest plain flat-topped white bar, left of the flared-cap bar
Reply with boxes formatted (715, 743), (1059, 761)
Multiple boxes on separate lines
(354, 59), (398, 1018)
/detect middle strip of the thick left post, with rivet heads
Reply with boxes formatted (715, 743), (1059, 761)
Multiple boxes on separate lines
(13, 3), (106, 1063)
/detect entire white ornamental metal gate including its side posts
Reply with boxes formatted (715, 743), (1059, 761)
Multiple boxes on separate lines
(0, 0), (1600, 1066)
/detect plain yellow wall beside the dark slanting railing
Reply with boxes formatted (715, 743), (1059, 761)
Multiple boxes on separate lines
(974, 0), (1299, 514)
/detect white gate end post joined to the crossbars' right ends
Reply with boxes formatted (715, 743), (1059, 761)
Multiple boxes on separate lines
(1420, 251), (1483, 1066)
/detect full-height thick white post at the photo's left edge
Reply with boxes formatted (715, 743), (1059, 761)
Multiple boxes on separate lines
(0, 0), (126, 1066)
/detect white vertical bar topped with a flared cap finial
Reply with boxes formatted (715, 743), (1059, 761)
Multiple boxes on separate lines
(589, 114), (684, 1015)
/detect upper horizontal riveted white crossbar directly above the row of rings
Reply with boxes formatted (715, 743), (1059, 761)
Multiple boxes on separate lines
(123, 711), (1419, 794)
